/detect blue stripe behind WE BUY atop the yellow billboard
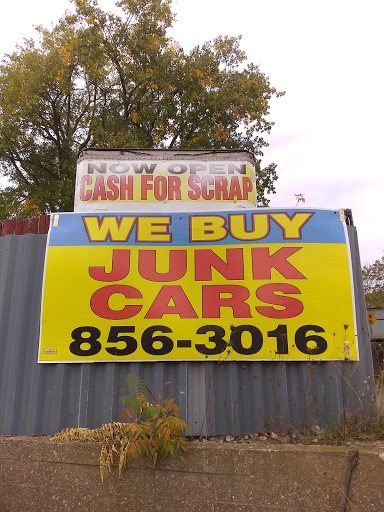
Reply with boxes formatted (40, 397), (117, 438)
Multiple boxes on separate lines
(49, 208), (345, 247)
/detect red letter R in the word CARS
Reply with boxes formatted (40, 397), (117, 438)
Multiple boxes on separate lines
(202, 284), (251, 318)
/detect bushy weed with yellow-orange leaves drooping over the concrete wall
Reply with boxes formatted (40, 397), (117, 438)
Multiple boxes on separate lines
(52, 374), (190, 481)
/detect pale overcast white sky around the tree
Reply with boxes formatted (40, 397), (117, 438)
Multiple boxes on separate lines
(0, 0), (384, 263)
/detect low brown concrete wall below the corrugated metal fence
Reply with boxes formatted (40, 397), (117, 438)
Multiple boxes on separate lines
(0, 436), (384, 512)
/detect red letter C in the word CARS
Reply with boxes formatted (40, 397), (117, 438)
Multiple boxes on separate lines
(90, 284), (143, 320)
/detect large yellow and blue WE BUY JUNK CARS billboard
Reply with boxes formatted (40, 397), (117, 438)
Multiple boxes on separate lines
(39, 208), (358, 363)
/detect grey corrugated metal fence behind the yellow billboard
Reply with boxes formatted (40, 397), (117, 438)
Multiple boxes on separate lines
(0, 218), (374, 436)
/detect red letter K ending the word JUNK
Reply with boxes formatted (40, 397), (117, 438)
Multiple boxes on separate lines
(252, 247), (306, 279)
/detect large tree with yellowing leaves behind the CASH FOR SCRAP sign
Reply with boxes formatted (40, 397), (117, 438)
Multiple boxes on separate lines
(0, 0), (283, 211)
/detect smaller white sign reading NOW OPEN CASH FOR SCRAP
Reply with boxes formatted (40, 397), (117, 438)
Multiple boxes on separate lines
(74, 150), (256, 212)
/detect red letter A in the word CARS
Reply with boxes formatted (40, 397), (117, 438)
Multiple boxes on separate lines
(145, 285), (198, 318)
